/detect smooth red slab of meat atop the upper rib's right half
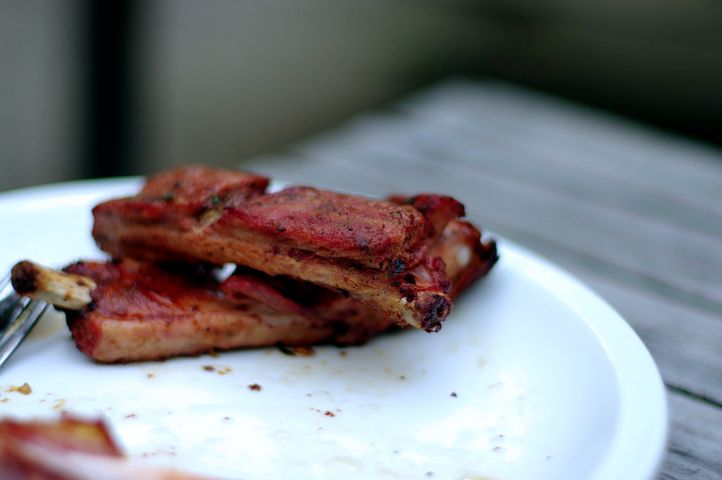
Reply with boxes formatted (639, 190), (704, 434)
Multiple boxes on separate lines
(228, 187), (426, 269)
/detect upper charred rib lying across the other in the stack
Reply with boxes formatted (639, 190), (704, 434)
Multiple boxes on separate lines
(93, 167), (472, 331)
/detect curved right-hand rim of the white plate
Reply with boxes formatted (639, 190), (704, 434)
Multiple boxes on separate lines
(498, 242), (669, 480)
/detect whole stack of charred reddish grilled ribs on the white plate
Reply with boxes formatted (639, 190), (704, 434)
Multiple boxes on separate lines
(13, 167), (497, 362)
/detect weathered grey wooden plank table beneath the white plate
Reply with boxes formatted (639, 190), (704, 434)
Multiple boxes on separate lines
(243, 81), (722, 480)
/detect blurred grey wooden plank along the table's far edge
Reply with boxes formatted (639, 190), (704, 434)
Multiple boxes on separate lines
(401, 81), (722, 209)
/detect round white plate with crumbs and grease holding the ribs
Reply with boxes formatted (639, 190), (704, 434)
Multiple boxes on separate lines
(0, 179), (667, 480)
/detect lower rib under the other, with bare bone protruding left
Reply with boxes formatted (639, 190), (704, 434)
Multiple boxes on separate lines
(12, 212), (496, 363)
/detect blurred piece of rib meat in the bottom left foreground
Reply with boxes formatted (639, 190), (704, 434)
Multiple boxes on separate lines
(0, 416), (210, 480)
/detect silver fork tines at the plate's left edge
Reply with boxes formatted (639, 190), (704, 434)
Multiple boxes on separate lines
(0, 274), (48, 368)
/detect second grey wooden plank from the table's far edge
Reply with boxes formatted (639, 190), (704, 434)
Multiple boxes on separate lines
(328, 115), (722, 238)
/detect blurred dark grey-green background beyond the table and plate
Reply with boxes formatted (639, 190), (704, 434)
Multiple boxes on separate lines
(0, 0), (722, 190)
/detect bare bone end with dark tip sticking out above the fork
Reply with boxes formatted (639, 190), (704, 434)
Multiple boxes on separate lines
(11, 260), (96, 310)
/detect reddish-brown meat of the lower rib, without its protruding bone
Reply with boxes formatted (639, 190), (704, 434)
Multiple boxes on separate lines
(59, 259), (390, 363)
